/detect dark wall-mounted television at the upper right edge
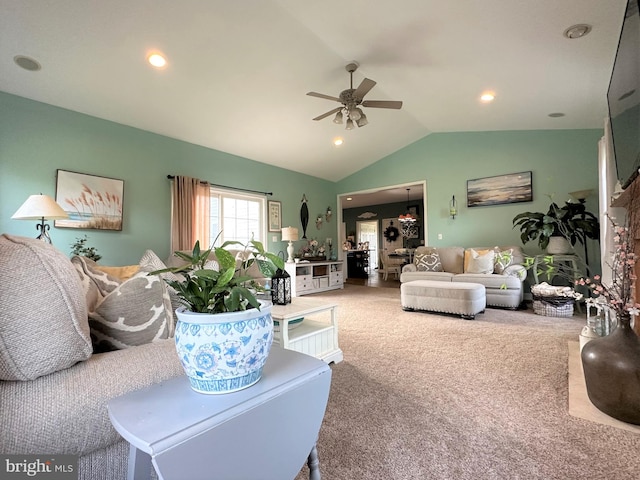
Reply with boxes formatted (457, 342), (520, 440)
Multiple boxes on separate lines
(607, 0), (640, 188)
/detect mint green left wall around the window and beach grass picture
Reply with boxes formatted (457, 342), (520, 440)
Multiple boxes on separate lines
(0, 92), (337, 265)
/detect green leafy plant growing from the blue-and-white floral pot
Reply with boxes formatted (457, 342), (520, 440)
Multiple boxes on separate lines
(150, 240), (284, 313)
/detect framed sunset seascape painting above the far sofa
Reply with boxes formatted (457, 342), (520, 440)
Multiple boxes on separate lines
(467, 172), (533, 207)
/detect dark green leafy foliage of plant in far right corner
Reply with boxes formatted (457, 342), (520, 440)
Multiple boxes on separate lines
(513, 202), (600, 250)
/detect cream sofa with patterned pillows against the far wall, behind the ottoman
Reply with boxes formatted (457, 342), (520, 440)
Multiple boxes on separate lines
(400, 246), (527, 309)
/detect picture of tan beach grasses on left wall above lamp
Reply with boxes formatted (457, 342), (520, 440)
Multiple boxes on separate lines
(54, 170), (124, 231)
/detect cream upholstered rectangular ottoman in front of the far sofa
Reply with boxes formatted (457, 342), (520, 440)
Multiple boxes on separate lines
(400, 280), (487, 320)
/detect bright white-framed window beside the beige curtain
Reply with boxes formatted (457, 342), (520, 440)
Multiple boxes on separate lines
(209, 187), (266, 246)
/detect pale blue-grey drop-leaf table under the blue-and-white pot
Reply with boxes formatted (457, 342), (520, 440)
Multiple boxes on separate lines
(107, 345), (331, 480)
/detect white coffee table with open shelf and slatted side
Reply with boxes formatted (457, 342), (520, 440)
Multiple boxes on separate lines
(271, 297), (343, 363)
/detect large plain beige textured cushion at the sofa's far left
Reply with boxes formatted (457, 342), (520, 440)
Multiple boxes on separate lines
(0, 234), (92, 380)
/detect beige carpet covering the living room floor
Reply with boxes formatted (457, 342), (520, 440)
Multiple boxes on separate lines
(296, 285), (640, 480)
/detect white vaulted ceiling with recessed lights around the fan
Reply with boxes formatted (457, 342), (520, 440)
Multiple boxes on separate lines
(0, 0), (626, 185)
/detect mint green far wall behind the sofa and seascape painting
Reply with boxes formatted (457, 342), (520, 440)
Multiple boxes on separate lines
(337, 129), (603, 265)
